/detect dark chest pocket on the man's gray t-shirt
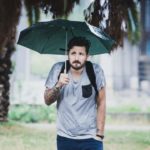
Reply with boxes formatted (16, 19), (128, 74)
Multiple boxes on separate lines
(82, 84), (92, 98)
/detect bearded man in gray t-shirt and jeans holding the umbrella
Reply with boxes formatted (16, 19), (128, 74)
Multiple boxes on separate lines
(44, 37), (106, 150)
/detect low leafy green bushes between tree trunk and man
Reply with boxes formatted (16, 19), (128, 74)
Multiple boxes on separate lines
(8, 105), (56, 123)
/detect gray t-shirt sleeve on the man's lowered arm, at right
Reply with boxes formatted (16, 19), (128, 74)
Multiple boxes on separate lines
(93, 64), (106, 90)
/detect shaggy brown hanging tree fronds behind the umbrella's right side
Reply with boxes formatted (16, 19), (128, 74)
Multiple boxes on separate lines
(84, 0), (140, 47)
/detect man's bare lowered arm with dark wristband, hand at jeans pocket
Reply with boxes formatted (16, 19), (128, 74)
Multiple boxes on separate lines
(97, 87), (106, 137)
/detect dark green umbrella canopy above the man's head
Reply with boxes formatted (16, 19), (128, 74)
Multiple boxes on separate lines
(18, 19), (115, 55)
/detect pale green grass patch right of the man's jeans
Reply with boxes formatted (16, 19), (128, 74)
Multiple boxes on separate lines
(105, 131), (150, 150)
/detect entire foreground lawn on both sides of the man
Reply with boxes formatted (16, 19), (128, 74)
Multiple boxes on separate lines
(0, 122), (150, 150)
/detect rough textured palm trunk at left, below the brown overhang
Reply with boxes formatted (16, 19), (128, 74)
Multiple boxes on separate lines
(0, 38), (14, 122)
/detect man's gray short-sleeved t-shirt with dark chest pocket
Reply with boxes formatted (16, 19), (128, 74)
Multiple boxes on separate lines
(45, 62), (105, 139)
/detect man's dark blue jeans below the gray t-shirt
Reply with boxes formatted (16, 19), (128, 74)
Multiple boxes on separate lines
(57, 135), (103, 150)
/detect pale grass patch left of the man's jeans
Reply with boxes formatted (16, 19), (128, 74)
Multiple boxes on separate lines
(0, 123), (55, 150)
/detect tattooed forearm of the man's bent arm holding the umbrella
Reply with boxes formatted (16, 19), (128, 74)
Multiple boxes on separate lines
(44, 86), (60, 105)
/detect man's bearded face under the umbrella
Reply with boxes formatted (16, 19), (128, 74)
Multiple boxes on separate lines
(68, 46), (88, 70)
